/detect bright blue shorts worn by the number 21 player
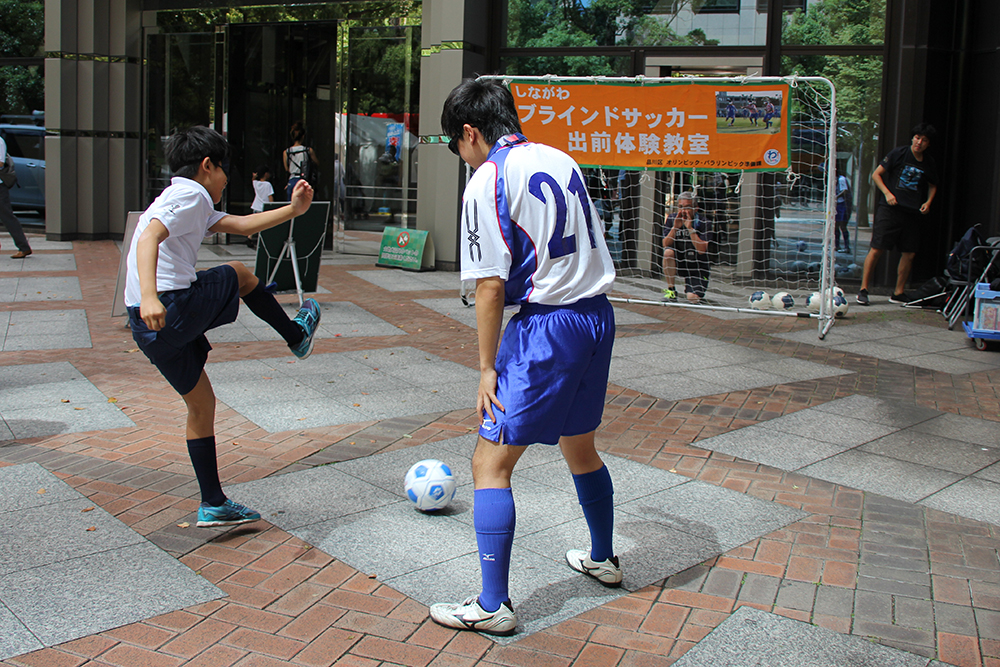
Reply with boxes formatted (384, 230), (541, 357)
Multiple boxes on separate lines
(479, 295), (615, 446)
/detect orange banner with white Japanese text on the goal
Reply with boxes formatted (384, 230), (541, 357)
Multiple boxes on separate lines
(510, 79), (789, 171)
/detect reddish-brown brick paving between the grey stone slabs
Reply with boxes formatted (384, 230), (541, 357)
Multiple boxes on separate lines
(0, 235), (1000, 667)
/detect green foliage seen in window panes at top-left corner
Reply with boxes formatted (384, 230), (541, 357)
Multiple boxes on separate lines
(0, 0), (45, 114)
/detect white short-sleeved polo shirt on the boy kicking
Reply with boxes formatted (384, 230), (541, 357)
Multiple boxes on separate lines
(125, 176), (228, 306)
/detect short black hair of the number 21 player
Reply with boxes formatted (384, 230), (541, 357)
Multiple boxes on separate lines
(441, 79), (521, 146)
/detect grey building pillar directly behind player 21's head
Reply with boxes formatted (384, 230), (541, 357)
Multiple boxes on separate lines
(417, 0), (486, 271)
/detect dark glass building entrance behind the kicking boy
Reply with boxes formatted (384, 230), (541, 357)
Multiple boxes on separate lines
(144, 20), (420, 254)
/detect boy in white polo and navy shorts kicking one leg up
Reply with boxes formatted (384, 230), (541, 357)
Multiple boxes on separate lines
(125, 127), (320, 527)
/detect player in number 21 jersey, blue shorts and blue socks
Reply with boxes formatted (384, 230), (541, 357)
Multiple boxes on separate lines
(430, 80), (622, 635)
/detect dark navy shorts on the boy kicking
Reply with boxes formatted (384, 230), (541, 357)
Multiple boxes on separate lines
(128, 264), (240, 396)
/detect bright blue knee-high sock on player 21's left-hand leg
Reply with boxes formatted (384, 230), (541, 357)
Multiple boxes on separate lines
(473, 488), (516, 611)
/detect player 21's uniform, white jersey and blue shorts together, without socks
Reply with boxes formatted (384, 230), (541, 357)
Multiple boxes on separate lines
(462, 134), (615, 446)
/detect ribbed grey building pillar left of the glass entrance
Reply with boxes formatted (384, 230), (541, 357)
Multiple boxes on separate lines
(45, 0), (142, 240)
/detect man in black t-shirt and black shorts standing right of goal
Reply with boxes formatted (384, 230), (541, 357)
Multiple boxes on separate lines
(858, 123), (938, 306)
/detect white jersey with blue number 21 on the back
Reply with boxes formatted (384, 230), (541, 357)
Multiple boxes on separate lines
(461, 134), (615, 306)
